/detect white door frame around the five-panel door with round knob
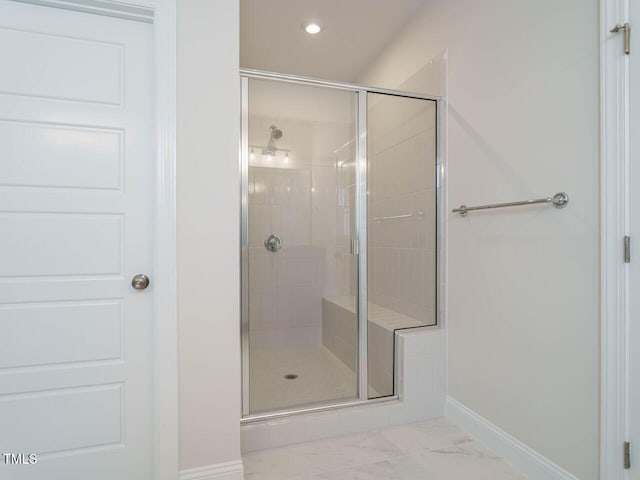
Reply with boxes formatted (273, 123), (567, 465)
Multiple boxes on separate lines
(10, 0), (179, 480)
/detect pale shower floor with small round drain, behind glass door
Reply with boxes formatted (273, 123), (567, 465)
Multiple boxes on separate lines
(249, 345), (364, 414)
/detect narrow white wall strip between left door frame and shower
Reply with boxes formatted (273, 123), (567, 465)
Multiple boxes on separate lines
(178, 0), (240, 470)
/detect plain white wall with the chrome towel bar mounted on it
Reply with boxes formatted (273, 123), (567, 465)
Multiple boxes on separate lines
(358, 0), (599, 480)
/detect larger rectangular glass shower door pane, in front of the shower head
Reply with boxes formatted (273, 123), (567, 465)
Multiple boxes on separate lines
(244, 78), (357, 414)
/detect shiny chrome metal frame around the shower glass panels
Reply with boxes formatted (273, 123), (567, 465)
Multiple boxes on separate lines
(239, 69), (443, 423)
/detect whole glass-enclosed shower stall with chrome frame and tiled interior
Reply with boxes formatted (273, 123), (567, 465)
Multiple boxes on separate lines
(240, 70), (441, 419)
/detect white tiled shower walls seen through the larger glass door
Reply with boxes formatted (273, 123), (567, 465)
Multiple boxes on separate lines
(249, 116), (354, 349)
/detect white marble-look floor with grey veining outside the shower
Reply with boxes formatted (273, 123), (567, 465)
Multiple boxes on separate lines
(243, 418), (526, 480)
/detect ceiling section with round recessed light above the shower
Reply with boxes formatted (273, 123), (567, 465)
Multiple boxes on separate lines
(240, 0), (426, 82)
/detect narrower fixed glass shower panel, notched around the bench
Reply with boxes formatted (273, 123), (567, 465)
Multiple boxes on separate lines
(367, 93), (438, 398)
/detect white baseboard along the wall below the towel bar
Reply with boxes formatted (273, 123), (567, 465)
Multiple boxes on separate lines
(445, 396), (578, 480)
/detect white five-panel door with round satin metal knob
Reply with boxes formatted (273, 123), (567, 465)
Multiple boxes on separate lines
(0, 0), (154, 480)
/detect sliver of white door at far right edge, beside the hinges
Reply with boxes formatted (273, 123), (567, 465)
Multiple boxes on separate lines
(620, 1), (640, 480)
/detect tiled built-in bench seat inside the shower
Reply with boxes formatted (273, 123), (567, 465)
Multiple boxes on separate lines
(322, 295), (427, 396)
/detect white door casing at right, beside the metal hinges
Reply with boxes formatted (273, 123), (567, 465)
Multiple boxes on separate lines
(599, 0), (629, 480)
